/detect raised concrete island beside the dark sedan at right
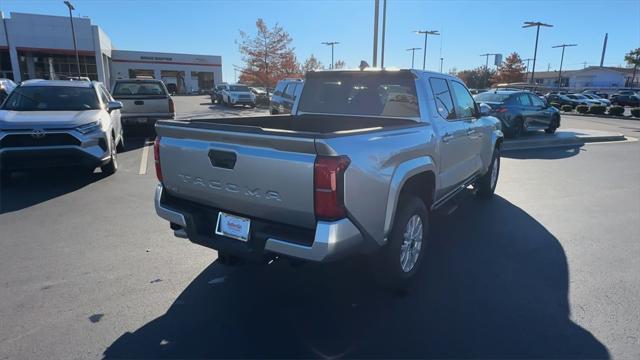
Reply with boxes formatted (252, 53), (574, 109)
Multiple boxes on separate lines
(502, 129), (627, 151)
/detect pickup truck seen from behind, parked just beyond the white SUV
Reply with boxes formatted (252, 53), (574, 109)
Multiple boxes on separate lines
(113, 79), (176, 124)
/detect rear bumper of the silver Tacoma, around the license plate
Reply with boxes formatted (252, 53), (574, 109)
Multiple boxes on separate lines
(155, 185), (364, 262)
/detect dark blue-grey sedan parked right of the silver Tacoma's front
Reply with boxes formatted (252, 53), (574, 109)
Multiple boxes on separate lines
(474, 90), (560, 137)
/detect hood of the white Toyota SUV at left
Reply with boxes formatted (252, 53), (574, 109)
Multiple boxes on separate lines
(0, 110), (101, 130)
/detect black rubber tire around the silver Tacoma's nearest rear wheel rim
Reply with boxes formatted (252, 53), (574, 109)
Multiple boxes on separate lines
(371, 195), (429, 290)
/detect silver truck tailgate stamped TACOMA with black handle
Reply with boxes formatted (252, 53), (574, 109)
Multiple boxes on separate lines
(156, 122), (316, 228)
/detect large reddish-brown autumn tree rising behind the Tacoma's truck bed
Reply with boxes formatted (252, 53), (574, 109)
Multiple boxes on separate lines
(239, 19), (302, 88)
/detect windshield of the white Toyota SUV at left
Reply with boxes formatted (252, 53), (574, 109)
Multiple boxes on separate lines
(2, 86), (100, 111)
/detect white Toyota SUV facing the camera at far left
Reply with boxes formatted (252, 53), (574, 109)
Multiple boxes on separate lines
(0, 80), (124, 178)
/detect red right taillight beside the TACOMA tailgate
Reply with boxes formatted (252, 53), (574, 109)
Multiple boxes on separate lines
(313, 156), (351, 220)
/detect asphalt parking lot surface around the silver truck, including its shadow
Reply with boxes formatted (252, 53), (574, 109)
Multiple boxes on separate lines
(0, 96), (640, 359)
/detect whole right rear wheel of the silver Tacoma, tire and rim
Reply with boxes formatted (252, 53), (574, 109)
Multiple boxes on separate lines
(372, 195), (429, 290)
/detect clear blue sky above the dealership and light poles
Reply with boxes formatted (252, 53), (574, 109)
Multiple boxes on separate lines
(0, 0), (640, 81)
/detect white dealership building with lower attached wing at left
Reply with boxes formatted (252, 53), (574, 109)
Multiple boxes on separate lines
(0, 12), (222, 93)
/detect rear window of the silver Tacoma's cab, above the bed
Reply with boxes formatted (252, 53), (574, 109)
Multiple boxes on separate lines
(298, 72), (420, 117)
